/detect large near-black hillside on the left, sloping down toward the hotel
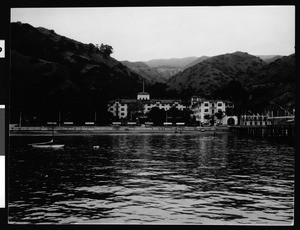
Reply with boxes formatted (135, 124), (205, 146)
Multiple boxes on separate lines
(10, 22), (150, 124)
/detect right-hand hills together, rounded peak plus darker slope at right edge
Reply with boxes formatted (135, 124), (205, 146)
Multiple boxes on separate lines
(167, 52), (296, 110)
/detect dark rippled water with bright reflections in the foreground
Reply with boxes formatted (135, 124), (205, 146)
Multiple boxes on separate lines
(8, 133), (295, 225)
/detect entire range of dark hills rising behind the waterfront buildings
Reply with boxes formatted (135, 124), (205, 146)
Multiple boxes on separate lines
(10, 23), (295, 119)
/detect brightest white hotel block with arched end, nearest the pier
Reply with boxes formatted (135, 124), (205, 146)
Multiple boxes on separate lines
(190, 96), (238, 125)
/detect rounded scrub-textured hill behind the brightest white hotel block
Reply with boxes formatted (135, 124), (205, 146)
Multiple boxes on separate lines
(168, 52), (264, 97)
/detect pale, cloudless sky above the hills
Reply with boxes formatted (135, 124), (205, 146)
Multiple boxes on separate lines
(11, 6), (295, 61)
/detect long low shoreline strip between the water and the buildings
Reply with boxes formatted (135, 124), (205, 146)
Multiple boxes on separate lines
(9, 126), (229, 136)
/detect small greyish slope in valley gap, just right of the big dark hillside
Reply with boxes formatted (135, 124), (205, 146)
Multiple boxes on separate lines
(121, 61), (166, 84)
